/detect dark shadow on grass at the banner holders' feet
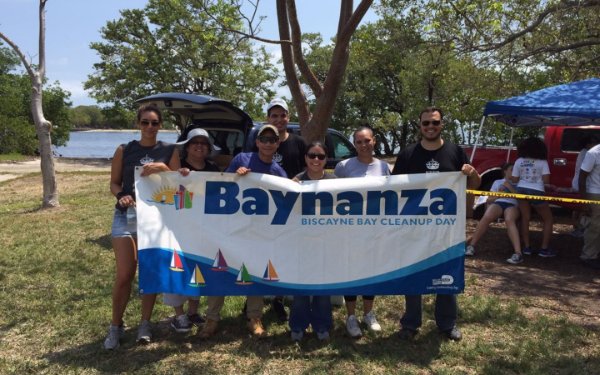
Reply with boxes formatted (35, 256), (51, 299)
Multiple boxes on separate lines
(44, 311), (444, 374)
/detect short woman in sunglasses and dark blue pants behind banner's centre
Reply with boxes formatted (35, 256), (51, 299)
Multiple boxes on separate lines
(289, 141), (336, 341)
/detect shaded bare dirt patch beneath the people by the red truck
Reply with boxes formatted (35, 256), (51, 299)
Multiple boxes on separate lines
(465, 214), (600, 329)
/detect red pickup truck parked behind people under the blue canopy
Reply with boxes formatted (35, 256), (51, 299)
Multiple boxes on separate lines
(463, 126), (600, 214)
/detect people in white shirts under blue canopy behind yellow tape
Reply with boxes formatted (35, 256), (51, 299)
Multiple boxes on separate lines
(465, 135), (600, 268)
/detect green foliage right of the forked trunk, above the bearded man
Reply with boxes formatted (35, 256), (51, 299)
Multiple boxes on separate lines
(303, 0), (600, 154)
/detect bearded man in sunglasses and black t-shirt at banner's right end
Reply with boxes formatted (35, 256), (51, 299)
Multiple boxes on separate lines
(392, 107), (481, 341)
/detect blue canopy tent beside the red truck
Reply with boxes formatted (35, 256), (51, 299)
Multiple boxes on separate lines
(471, 78), (600, 161)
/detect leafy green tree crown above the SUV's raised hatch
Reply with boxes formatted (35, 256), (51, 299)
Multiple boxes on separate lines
(85, 0), (276, 121)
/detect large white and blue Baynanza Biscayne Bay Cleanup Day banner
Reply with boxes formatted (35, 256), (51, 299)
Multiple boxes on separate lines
(136, 170), (466, 296)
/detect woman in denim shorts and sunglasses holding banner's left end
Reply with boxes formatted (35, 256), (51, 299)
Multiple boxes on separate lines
(104, 104), (179, 350)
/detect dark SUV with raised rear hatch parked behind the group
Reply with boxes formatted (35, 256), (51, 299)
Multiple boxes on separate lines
(136, 93), (356, 169)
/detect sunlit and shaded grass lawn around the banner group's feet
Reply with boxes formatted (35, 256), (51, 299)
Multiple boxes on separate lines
(0, 173), (600, 374)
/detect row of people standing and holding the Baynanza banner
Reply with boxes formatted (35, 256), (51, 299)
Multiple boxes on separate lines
(104, 99), (481, 349)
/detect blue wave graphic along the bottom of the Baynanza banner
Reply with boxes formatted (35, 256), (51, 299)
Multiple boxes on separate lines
(138, 242), (465, 296)
